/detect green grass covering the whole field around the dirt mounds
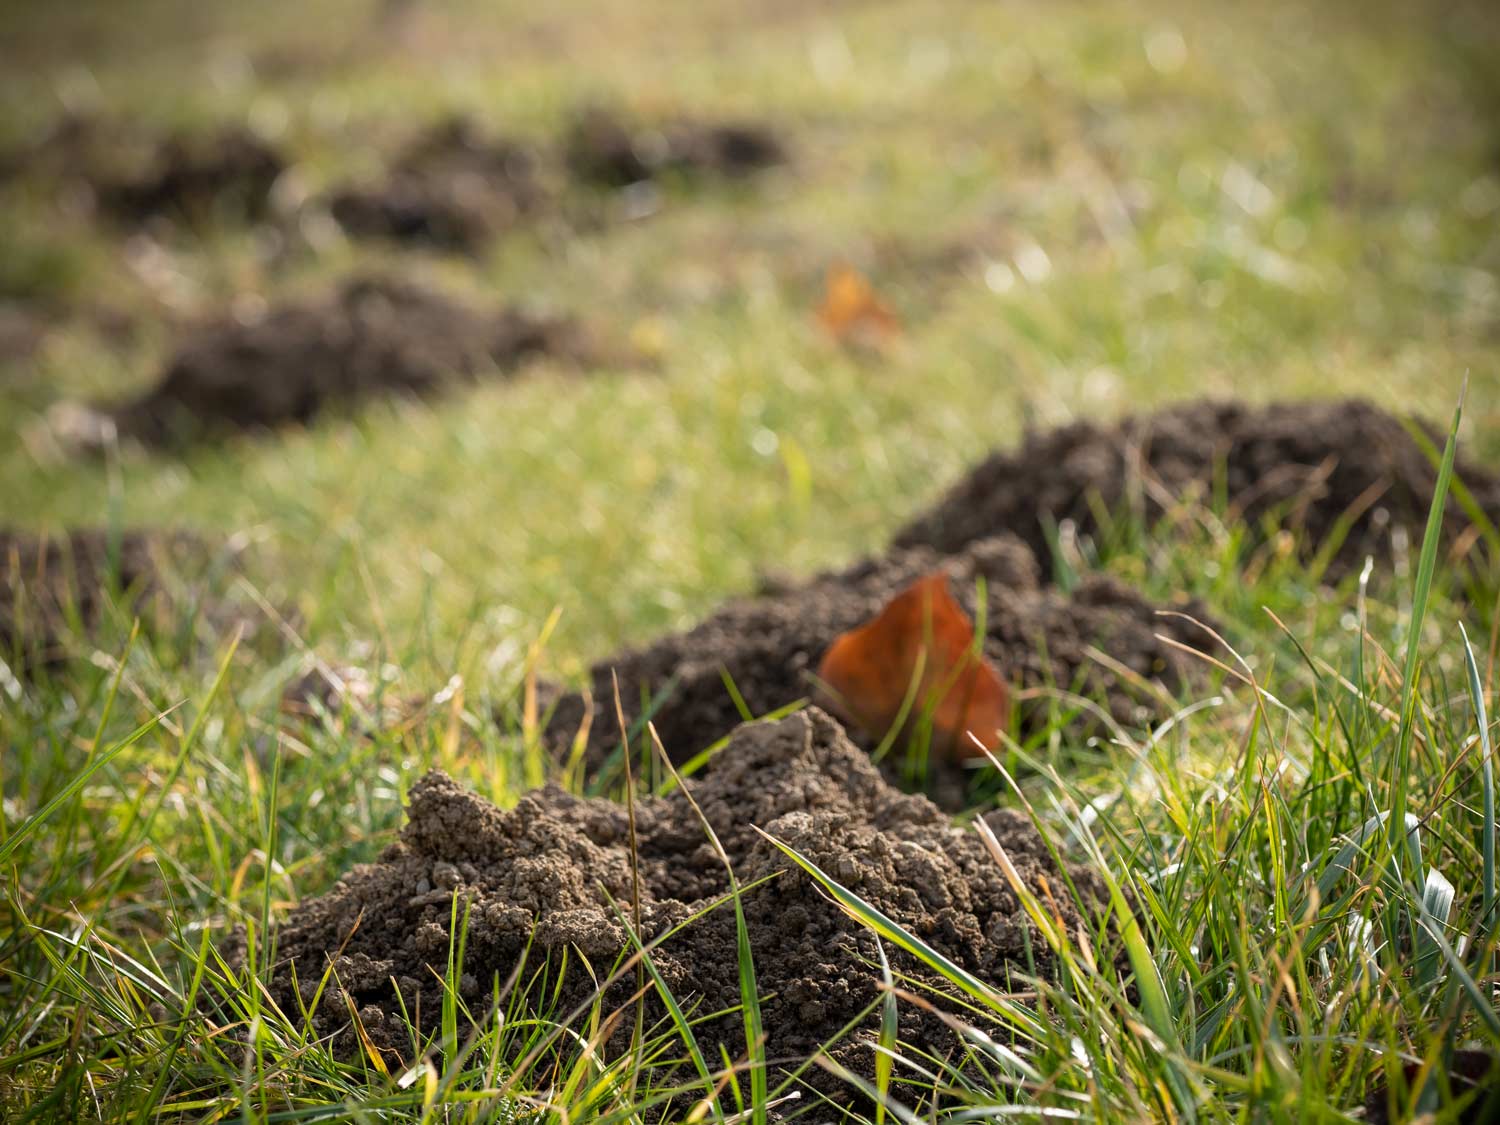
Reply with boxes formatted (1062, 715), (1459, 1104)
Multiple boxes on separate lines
(0, 0), (1500, 1122)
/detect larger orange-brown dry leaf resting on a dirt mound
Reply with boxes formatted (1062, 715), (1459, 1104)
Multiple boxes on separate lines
(818, 573), (1010, 762)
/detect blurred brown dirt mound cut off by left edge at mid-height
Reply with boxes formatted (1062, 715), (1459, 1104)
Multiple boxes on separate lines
(0, 528), (236, 672)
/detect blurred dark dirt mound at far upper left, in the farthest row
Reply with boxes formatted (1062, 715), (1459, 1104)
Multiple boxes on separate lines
(93, 126), (287, 222)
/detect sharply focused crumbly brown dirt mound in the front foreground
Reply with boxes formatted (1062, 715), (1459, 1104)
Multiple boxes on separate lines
(261, 710), (1101, 1097)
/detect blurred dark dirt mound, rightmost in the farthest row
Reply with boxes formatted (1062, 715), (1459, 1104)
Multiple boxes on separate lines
(564, 107), (786, 188)
